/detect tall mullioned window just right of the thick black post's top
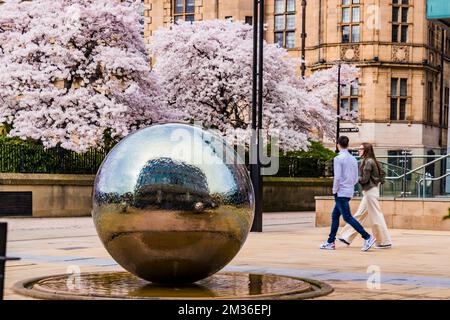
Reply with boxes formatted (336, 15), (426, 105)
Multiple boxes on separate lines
(274, 0), (295, 49)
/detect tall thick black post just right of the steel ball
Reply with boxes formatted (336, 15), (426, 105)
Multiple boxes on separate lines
(250, 0), (265, 232)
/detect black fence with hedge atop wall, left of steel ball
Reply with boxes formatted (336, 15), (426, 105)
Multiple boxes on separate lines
(0, 143), (107, 174)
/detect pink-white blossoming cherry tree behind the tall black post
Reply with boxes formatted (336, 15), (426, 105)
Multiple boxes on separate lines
(150, 20), (358, 150)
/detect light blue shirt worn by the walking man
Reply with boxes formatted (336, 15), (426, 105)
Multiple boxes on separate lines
(333, 150), (359, 198)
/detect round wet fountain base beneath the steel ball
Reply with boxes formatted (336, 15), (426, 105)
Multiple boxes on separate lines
(13, 272), (333, 300)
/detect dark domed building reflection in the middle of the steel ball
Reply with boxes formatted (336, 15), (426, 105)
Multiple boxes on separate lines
(134, 158), (214, 210)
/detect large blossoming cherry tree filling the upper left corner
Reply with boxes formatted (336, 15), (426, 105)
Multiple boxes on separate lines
(0, 0), (169, 152)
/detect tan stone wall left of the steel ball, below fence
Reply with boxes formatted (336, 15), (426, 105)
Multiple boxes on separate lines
(0, 173), (95, 217)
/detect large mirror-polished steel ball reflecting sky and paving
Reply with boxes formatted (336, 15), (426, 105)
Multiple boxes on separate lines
(92, 124), (254, 284)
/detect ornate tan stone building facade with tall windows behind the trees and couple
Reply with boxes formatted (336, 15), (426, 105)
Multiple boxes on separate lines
(144, 0), (450, 160)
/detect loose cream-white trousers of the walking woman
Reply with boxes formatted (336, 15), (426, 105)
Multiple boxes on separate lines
(339, 187), (392, 245)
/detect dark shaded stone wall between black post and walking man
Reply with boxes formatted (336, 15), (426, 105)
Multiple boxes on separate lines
(263, 177), (333, 212)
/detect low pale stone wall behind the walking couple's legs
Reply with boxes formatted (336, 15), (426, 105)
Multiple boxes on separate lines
(316, 197), (450, 231)
